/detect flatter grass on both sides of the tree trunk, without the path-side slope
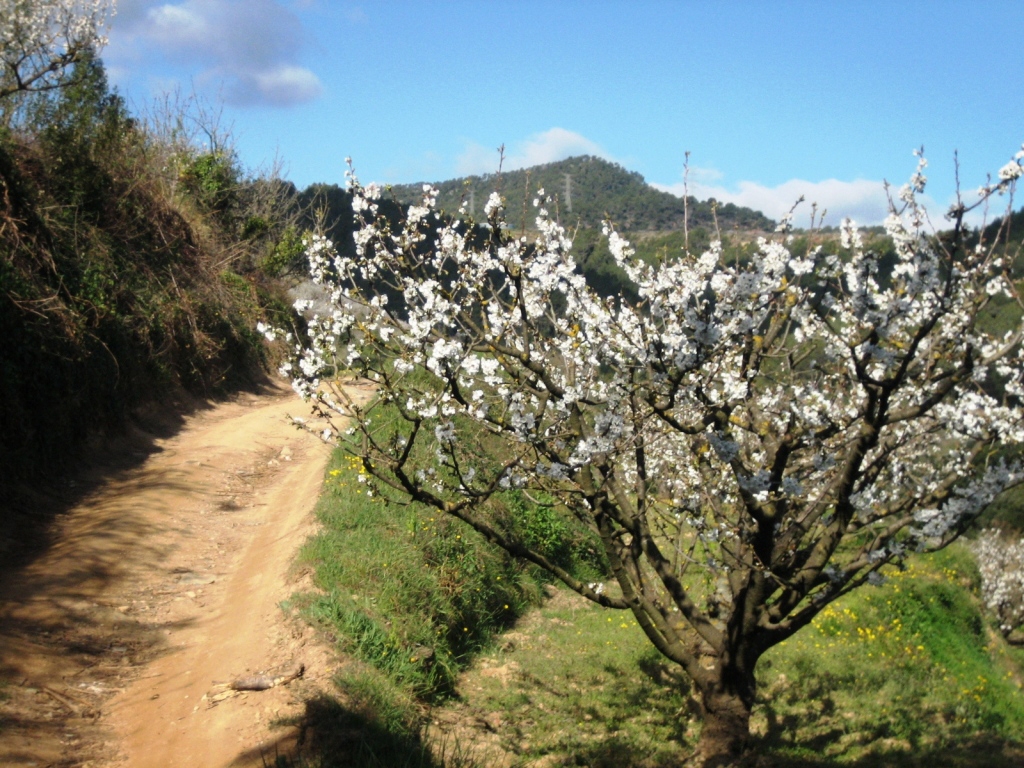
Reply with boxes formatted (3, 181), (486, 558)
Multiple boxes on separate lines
(417, 548), (1024, 768)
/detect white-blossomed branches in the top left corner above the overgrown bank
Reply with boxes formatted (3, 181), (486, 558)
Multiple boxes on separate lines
(0, 0), (115, 98)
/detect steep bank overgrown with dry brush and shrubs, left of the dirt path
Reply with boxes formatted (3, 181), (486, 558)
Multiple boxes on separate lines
(0, 60), (294, 551)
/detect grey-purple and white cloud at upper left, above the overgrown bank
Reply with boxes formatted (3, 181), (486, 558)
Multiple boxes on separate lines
(109, 0), (323, 106)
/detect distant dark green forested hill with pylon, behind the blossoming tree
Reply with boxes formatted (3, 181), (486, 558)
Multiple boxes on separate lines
(393, 156), (775, 232)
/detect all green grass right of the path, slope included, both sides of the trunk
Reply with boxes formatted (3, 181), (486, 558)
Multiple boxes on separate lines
(296, 405), (1024, 768)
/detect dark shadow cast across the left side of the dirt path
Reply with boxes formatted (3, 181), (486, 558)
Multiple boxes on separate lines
(0, 372), (272, 765)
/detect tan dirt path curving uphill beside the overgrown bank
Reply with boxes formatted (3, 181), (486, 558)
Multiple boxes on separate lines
(0, 391), (372, 768)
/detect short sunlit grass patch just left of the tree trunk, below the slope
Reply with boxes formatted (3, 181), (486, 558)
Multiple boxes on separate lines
(438, 590), (695, 768)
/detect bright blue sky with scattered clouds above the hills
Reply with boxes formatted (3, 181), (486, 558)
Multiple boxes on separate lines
(103, 0), (1024, 224)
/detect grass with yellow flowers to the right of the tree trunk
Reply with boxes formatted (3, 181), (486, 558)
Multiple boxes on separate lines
(754, 547), (1024, 766)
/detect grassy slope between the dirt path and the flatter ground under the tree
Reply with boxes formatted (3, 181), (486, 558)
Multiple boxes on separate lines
(295, 397), (603, 766)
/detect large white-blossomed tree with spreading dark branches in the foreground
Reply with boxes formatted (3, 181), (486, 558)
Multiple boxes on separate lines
(276, 152), (1024, 765)
